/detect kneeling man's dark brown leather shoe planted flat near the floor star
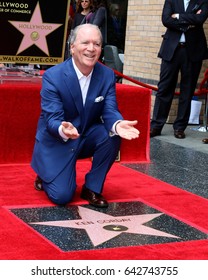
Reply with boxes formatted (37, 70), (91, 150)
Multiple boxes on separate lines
(81, 186), (108, 208)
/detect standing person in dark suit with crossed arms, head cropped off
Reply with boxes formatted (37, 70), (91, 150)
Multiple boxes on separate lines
(150, 0), (208, 139)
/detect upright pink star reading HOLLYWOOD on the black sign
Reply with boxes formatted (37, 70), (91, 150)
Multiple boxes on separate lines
(9, 3), (62, 56)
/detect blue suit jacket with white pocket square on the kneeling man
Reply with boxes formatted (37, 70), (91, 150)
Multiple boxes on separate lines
(31, 59), (123, 182)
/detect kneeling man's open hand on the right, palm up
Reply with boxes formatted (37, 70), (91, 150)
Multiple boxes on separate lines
(116, 120), (139, 140)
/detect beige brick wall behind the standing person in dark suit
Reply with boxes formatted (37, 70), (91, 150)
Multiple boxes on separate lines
(124, 0), (208, 85)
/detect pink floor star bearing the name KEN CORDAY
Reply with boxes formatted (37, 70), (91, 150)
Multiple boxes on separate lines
(30, 206), (179, 246)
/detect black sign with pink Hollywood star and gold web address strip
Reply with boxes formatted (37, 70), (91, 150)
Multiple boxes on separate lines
(0, 0), (70, 65)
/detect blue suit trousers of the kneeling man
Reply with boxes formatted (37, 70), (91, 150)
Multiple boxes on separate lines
(43, 124), (121, 205)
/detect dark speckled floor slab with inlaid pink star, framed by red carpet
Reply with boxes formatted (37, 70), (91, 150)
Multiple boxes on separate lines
(10, 201), (207, 251)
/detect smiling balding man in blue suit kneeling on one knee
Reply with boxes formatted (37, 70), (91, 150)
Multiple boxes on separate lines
(31, 24), (139, 207)
